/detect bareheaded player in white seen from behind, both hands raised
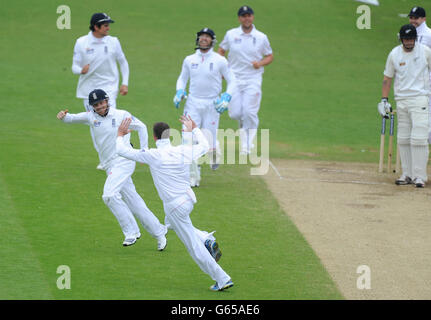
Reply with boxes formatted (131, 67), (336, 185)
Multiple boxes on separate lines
(117, 116), (233, 291)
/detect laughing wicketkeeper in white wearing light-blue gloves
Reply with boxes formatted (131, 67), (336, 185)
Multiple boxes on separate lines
(173, 28), (236, 187)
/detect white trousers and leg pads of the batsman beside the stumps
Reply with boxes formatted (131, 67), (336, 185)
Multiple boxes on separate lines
(397, 96), (429, 182)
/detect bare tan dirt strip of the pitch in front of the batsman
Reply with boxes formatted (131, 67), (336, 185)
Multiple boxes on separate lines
(263, 160), (431, 299)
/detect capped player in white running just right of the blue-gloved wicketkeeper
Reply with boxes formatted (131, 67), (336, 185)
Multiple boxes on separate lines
(218, 6), (273, 154)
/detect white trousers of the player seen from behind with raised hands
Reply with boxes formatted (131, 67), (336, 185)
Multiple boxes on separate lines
(164, 196), (230, 285)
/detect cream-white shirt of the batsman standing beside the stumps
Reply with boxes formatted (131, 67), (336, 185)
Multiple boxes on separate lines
(383, 43), (431, 100)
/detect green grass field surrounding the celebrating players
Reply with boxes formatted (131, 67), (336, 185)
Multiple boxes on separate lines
(0, 0), (431, 300)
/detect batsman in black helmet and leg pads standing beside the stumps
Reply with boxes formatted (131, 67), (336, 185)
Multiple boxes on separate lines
(377, 24), (431, 188)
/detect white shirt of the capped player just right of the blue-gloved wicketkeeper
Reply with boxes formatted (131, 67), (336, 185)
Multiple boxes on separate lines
(220, 25), (272, 81)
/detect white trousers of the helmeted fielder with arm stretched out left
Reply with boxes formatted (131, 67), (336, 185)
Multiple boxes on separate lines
(102, 157), (167, 238)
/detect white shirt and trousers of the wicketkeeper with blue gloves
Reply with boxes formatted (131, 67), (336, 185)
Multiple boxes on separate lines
(176, 49), (236, 149)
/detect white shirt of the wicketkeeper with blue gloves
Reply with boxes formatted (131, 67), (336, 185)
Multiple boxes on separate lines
(176, 50), (236, 99)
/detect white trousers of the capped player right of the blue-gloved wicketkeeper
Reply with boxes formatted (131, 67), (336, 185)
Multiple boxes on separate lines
(228, 77), (262, 150)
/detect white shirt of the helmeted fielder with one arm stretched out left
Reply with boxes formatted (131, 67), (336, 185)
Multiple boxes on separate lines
(63, 108), (148, 170)
